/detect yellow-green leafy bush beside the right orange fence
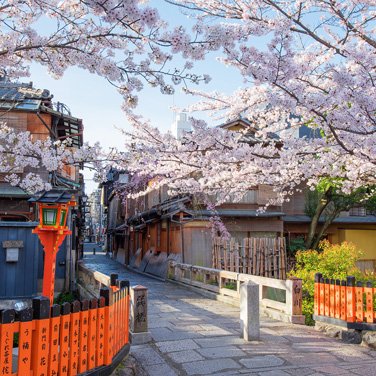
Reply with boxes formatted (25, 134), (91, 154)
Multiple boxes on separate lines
(290, 240), (363, 324)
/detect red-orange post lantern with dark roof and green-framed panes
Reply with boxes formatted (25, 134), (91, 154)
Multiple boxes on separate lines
(29, 190), (76, 305)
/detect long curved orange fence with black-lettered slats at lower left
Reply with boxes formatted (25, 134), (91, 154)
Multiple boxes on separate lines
(0, 281), (129, 376)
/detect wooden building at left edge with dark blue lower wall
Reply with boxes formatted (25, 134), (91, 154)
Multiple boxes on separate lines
(0, 80), (83, 303)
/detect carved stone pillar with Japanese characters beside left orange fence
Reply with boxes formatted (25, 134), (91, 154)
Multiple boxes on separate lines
(130, 285), (151, 345)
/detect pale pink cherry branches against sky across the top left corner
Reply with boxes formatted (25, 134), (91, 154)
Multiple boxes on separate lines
(0, 0), (208, 104)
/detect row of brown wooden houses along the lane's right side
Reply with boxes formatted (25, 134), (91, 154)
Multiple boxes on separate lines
(105, 120), (283, 274)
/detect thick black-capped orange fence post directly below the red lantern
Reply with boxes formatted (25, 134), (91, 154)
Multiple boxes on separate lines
(31, 296), (50, 375)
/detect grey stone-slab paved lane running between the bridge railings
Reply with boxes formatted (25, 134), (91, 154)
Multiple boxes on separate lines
(85, 255), (376, 376)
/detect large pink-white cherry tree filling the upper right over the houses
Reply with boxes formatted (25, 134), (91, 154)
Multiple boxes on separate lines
(128, 0), (376, 203)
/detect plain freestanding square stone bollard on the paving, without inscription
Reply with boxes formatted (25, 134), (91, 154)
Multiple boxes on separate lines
(240, 281), (260, 341)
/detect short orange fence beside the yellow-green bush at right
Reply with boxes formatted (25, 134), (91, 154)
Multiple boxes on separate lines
(314, 273), (376, 323)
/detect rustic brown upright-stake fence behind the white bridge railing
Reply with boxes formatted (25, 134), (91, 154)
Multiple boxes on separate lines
(212, 238), (287, 279)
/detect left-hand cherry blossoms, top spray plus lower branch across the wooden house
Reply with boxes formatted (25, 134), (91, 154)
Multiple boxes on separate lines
(0, 0), (209, 191)
